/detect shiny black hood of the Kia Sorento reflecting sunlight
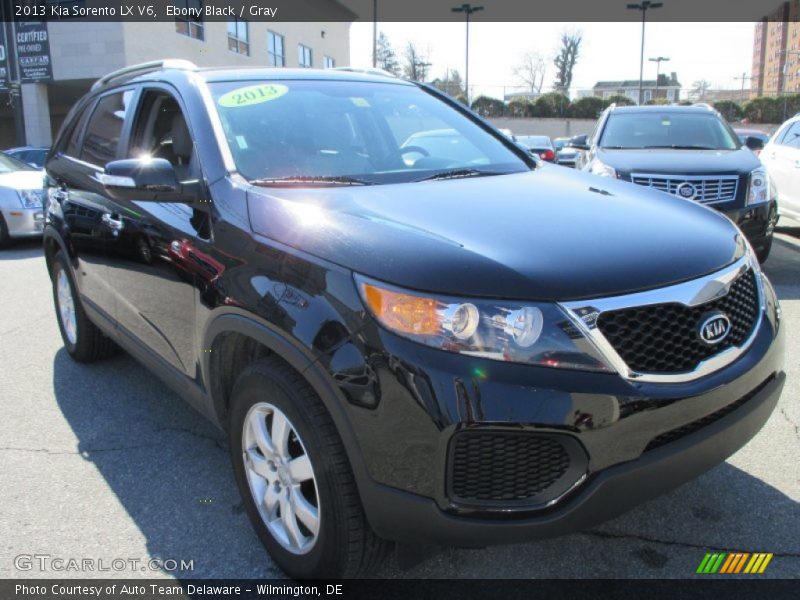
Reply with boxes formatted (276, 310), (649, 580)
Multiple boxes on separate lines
(248, 167), (741, 300)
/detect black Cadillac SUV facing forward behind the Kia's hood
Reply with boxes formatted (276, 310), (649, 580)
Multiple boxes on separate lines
(572, 104), (778, 262)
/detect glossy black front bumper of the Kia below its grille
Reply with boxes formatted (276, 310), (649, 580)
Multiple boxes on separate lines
(328, 274), (785, 546)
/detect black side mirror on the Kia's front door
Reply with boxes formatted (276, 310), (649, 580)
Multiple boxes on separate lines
(97, 158), (191, 202)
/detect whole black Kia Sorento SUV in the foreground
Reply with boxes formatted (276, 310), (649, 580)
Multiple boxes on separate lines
(44, 61), (784, 577)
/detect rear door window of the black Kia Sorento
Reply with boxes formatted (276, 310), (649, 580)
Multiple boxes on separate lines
(80, 90), (133, 167)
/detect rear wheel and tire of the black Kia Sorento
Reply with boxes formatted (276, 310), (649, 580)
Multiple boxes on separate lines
(50, 252), (118, 363)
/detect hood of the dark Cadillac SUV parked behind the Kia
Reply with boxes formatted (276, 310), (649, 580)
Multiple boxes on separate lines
(597, 148), (761, 175)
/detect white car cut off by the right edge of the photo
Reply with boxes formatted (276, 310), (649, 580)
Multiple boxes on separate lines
(759, 113), (800, 220)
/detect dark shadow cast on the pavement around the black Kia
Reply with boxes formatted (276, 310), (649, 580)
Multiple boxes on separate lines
(53, 349), (800, 578)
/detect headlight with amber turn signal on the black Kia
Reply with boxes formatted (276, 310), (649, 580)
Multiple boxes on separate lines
(356, 276), (612, 371)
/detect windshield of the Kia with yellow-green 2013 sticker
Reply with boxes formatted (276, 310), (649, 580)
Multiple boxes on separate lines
(209, 81), (529, 184)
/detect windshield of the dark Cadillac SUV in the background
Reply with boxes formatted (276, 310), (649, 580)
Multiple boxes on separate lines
(599, 111), (740, 150)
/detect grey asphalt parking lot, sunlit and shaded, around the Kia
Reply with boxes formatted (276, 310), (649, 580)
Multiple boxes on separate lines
(0, 227), (800, 578)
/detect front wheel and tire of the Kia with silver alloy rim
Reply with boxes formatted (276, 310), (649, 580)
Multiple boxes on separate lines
(229, 357), (391, 579)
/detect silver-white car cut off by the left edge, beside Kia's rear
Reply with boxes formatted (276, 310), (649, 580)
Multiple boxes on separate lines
(0, 152), (44, 248)
